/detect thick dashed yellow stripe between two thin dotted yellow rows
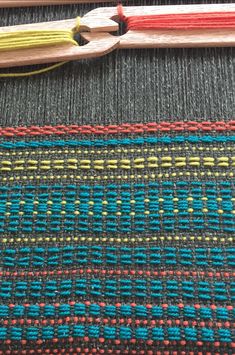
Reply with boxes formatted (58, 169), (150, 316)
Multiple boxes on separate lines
(0, 156), (235, 172)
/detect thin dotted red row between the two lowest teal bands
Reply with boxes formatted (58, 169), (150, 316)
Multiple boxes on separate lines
(0, 317), (232, 329)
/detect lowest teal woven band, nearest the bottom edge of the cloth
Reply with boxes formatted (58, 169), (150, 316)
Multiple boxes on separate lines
(0, 323), (232, 343)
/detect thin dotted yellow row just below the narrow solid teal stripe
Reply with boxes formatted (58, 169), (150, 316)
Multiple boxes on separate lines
(0, 145), (234, 157)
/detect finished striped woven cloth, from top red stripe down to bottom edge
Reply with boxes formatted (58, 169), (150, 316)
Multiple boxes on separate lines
(0, 121), (235, 355)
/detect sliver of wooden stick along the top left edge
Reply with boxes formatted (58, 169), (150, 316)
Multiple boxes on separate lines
(0, 0), (113, 8)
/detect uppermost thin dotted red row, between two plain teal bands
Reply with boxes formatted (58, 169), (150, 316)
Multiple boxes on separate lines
(0, 269), (235, 278)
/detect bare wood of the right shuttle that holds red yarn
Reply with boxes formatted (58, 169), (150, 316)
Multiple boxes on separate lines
(81, 4), (235, 48)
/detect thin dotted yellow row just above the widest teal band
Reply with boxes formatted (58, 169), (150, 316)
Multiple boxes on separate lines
(0, 170), (235, 183)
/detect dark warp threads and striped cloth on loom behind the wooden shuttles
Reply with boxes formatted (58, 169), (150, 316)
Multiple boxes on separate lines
(0, 1), (235, 355)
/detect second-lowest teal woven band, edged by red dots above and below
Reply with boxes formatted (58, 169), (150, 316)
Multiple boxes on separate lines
(0, 302), (235, 321)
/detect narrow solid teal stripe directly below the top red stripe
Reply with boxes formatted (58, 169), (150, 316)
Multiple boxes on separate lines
(0, 134), (235, 149)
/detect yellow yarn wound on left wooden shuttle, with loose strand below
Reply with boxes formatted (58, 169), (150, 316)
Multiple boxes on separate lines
(0, 17), (80, 78)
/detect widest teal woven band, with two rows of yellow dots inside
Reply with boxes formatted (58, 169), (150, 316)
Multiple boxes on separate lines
(0, 181), (235, 233)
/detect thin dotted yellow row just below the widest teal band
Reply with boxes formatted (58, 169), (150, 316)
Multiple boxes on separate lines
(0, 235), (235, 244)
